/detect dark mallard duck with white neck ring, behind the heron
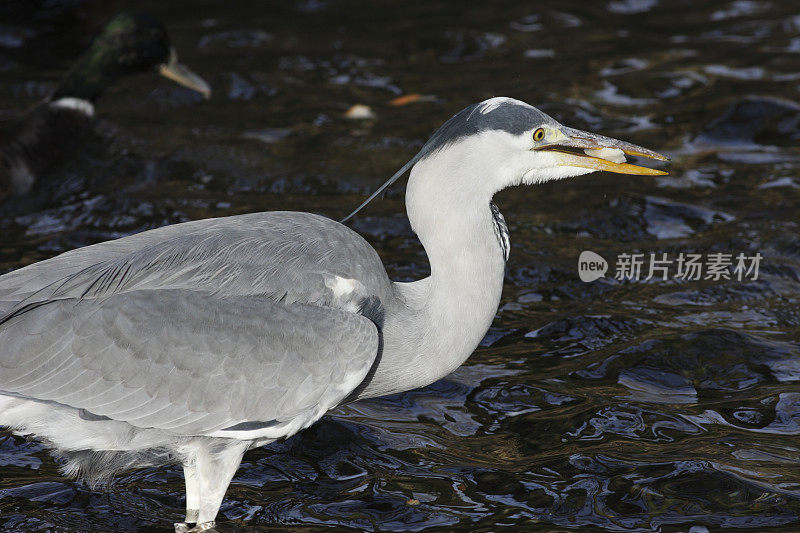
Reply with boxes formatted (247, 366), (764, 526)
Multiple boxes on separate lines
(0, 13), (211, 201)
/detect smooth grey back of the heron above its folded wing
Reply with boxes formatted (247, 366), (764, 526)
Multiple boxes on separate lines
(0, 212), (393, 316)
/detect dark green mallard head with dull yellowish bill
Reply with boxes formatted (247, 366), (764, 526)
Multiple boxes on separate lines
(51, 13), (211, 102)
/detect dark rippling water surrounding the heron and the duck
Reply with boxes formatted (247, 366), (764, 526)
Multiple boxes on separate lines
(0, 0), (800, 533)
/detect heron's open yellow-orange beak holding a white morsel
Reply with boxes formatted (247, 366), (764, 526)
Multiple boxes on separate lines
(534, 126), (669, 176)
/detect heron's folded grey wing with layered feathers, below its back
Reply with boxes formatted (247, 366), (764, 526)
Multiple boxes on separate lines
(0, 290), (379, 438)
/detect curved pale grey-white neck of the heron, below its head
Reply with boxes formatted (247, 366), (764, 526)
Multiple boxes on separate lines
(362, 156), (505, 397)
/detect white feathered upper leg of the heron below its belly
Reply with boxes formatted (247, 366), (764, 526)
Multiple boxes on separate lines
(187, 441), (250, 531)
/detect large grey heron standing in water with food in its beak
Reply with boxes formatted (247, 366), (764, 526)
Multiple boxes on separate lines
(0, 98), (666, 531)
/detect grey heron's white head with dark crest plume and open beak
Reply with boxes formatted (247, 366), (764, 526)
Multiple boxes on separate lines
(344, 97), (668, 220)
